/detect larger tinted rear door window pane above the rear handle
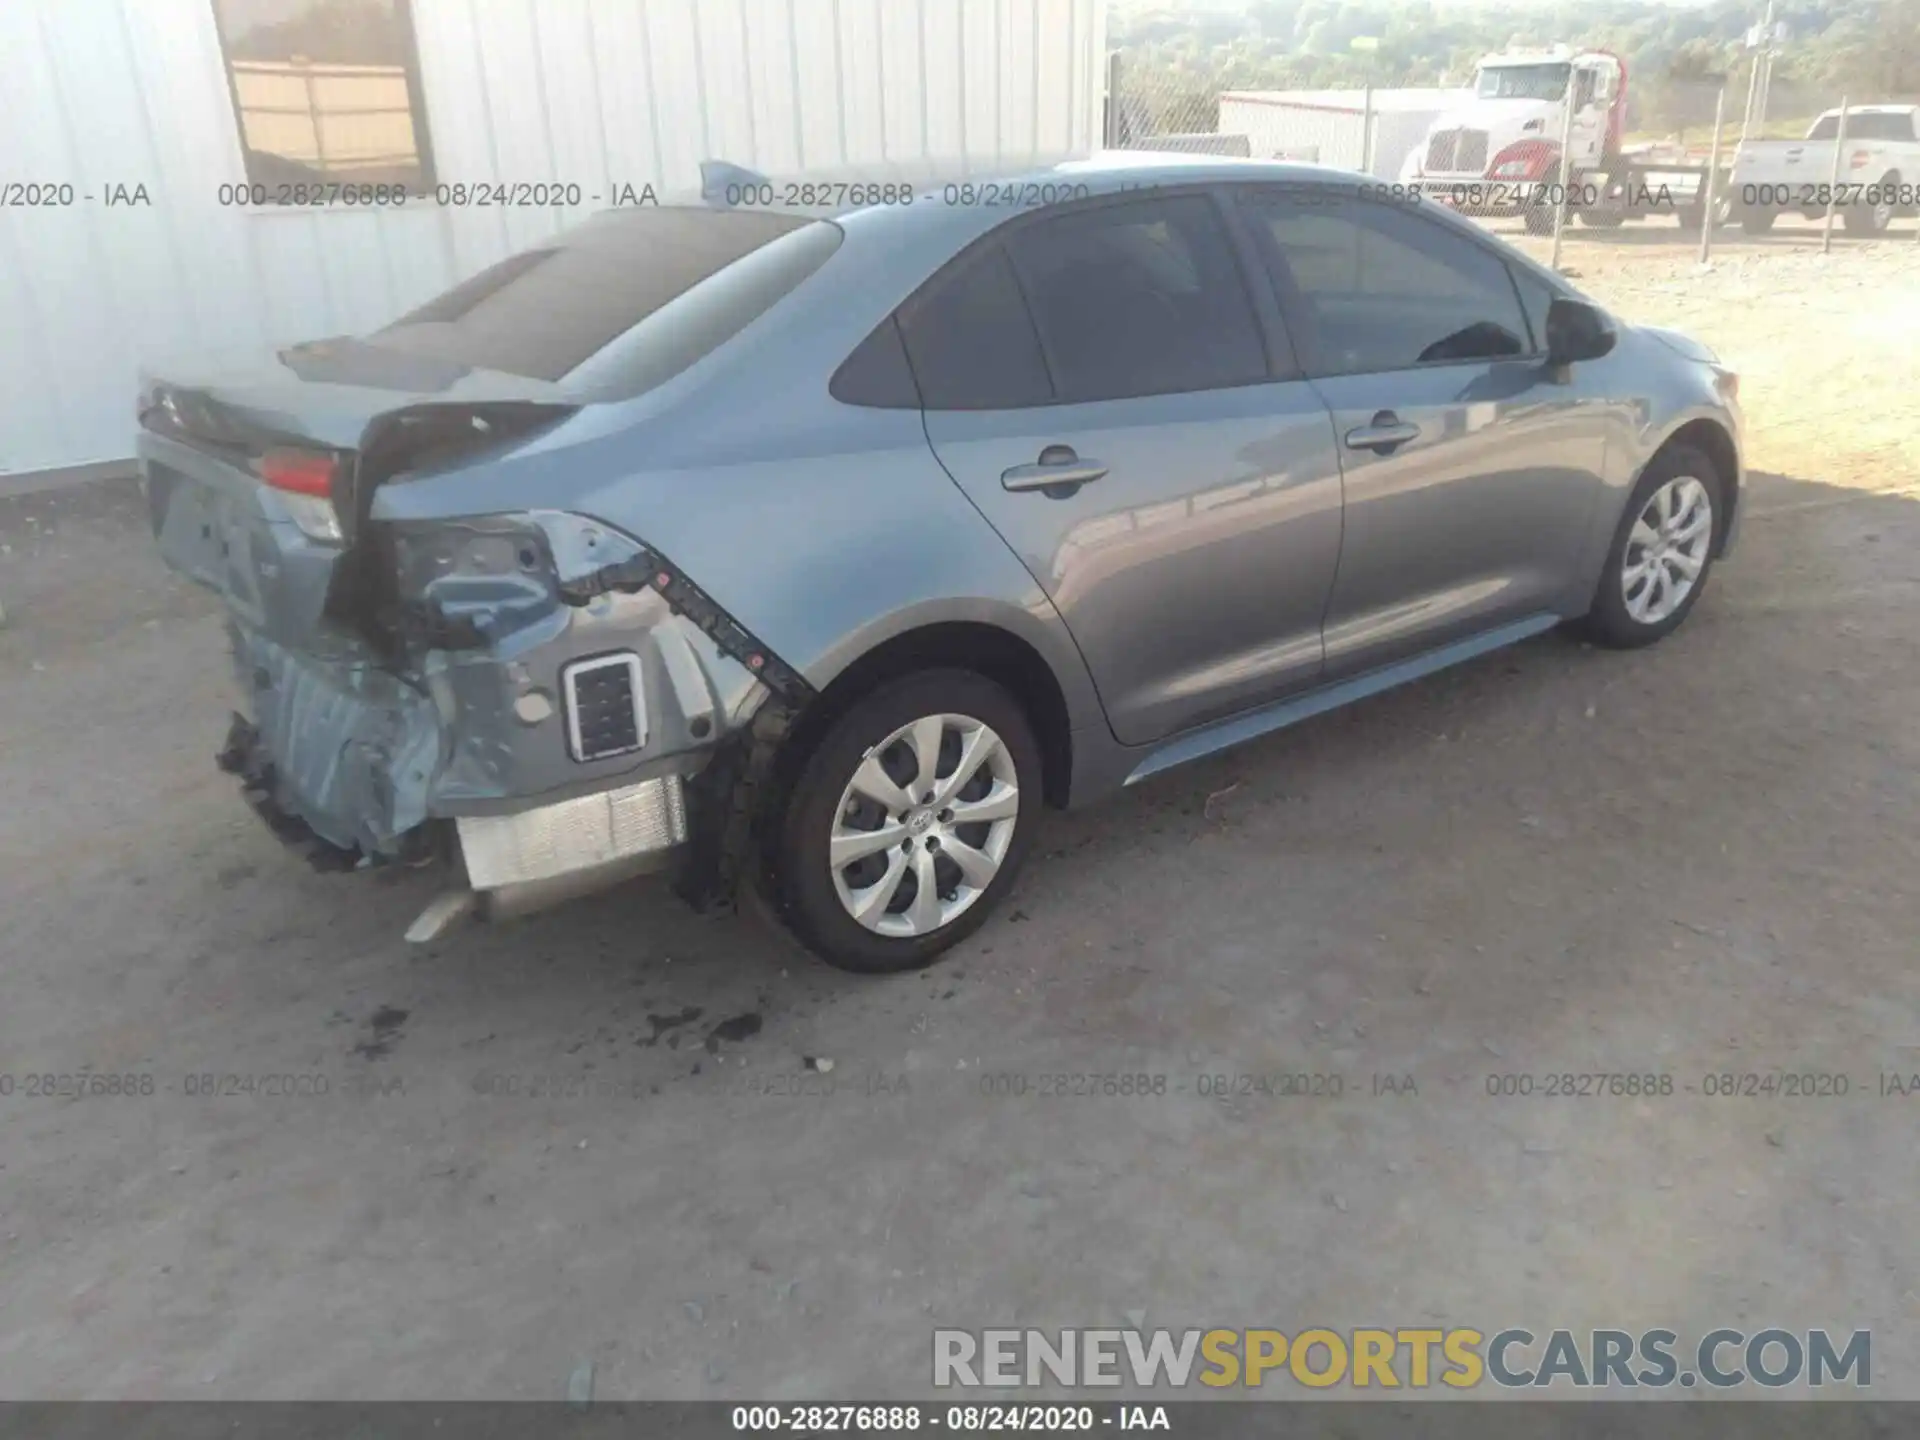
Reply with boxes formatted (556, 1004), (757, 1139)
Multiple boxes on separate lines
(1008, 196), (1267, 403)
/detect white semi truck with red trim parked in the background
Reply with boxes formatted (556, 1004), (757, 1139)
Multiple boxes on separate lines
(1400, 46), (1720, 234)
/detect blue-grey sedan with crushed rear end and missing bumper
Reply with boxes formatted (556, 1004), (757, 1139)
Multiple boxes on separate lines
(140, 157), (1741, 972)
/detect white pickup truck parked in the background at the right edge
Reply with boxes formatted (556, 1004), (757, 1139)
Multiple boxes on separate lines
(1728, 106), (1920, 234)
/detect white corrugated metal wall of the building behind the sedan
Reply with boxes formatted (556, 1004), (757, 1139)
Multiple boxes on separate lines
(0, 0), (1106, 474)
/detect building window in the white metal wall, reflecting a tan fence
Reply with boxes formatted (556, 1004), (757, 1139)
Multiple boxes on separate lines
(213, 0), (434, 194)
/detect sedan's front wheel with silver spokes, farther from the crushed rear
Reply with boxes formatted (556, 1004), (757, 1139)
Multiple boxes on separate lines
(1578, 445), (1726, 649)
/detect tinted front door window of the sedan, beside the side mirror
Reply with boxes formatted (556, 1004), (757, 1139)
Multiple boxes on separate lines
(1248, 190), (1530, 374)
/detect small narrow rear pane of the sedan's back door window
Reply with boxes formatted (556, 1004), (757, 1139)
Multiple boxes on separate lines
(899, 246), (1054, 411)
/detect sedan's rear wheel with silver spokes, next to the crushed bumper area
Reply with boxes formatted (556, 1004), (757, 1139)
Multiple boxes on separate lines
(772, 670), (1041, 973)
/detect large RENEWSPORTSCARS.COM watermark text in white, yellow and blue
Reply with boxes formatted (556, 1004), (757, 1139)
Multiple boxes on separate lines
(933, 1327), (1872, 1392)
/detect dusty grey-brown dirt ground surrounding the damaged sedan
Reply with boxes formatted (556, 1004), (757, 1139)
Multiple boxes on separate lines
(0, 227), (1920, 1398)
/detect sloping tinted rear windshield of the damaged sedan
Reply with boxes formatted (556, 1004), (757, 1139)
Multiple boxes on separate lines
(372, 205), (839, 380)
